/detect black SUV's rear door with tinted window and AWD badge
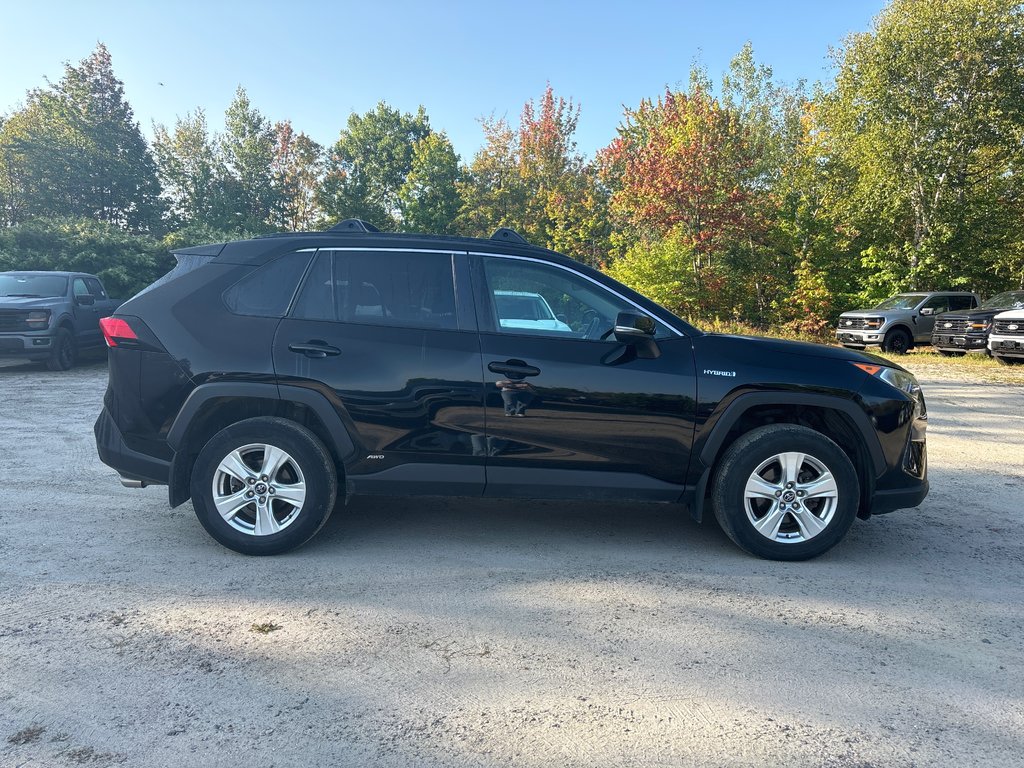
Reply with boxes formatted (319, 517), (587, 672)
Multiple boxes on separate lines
(273, 248), (485, 495)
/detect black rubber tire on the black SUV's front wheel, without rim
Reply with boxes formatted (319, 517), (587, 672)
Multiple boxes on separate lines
(711, 424), (860, 560)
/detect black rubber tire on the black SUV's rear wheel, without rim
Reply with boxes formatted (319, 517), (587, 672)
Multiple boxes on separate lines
(191, 417), (338, 555)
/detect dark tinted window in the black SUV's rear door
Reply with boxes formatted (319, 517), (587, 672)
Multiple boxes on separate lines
(292, 251), (459, 329)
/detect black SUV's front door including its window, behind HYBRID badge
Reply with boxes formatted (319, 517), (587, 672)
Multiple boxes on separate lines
(472, 254), (696, 501)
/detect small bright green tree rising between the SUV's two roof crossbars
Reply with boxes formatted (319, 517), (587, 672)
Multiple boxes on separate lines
(398, 133), (462, 234)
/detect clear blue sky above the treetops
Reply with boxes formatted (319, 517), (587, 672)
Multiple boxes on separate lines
(0, 0), (884, 159)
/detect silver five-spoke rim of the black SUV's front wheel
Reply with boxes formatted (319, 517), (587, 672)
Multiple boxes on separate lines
(743, 452), (839, 544)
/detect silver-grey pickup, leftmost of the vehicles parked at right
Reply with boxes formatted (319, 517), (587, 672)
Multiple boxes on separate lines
(836, 291), (979, 354)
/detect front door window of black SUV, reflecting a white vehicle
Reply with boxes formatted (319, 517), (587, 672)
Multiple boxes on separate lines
(483, 257), (666, 340)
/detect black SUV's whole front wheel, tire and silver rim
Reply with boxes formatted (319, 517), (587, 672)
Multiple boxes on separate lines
(711, 424), (860, 560)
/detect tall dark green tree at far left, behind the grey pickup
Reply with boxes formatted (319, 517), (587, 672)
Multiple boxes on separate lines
(0, 43), (161, 230)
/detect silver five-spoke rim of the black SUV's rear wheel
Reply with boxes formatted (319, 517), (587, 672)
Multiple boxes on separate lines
(207, 442), (306, 536)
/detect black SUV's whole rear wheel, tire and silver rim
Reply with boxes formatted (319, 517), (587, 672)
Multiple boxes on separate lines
(191, 417), (338, 555)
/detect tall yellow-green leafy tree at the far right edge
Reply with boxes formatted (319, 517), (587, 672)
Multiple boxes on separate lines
(821, 0), (1024, 295)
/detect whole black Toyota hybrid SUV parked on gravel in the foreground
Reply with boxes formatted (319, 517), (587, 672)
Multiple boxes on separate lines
(95, 220), (928, 560)
